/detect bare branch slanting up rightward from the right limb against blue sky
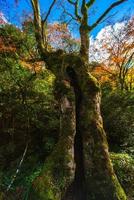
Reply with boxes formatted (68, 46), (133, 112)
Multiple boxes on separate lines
(89, 0), (127, 31)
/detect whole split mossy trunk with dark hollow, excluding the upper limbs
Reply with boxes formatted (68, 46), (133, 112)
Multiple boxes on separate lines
(27, 54), (127, 200)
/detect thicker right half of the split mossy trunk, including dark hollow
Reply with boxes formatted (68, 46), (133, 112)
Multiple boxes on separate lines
(70, 61), (127, 200)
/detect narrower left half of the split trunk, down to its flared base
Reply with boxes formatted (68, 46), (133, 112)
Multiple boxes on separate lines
(30, 79), (76, 200)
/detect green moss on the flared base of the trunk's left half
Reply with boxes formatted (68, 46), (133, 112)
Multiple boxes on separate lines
(30, 134), (74, 200)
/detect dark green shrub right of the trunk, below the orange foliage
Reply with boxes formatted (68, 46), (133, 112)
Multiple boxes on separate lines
(102, 92), (134, 153)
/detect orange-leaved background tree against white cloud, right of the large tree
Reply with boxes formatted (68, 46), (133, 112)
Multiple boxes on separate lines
(90, 18), (134, 90)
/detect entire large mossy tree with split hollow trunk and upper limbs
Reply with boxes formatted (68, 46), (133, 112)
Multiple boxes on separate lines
(25, 0), (127, 200)
